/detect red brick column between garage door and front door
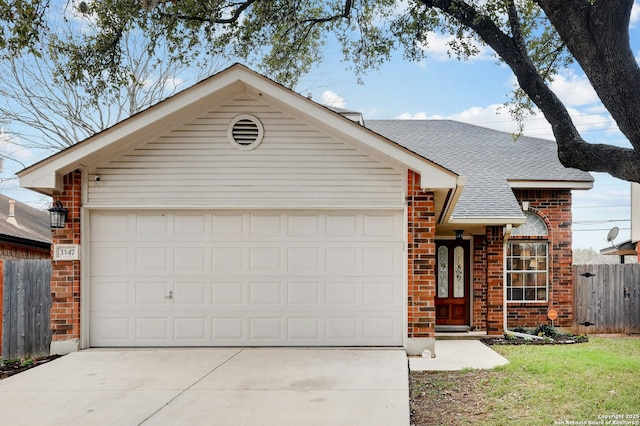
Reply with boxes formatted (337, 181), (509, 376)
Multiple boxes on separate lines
(407, 170), (436, 338)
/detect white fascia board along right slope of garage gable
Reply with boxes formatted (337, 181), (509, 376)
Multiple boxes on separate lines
(240, 74), (459, 189)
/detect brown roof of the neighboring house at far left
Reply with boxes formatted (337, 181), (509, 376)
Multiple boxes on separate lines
(0, 194), (51, 248)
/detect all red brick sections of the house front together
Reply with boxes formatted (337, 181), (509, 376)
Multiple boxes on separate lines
(46, 171), (573, 341)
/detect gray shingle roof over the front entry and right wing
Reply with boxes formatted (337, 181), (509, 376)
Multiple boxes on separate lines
(366, 120), (593, 223)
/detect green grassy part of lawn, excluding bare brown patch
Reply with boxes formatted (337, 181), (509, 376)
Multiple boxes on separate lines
(482, 338), (640, 425)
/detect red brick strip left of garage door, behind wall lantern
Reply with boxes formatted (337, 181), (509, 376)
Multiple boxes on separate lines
(51, 170), (82, 341)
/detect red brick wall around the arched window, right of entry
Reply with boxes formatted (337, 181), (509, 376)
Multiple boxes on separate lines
(508, 190), (573, 328)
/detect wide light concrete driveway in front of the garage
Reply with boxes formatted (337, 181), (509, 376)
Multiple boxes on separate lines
(0, 348), (409, 426)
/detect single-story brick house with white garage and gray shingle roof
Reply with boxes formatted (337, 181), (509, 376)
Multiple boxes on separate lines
(18, 64), (592, 354)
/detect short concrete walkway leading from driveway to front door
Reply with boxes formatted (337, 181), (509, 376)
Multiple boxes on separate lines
(409, 340), (509, 371)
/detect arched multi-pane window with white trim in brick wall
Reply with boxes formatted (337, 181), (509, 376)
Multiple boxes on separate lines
(506, 212), (549, 302)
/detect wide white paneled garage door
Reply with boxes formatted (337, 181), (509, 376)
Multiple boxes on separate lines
(89, 211), (404, 347)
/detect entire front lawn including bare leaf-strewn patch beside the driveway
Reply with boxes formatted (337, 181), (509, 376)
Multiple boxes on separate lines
(410, 337), (640, 425)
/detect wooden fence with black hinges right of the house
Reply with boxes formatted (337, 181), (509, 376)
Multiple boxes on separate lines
(573, 264), (640, 334)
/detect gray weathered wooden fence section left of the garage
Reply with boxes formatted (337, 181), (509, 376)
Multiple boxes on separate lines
(0, 259), (51, 359)
